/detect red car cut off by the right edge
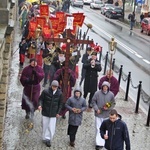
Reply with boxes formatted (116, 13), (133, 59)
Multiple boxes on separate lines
(141, 17), (150, 36)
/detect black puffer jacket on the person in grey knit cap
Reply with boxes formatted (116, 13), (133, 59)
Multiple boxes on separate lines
(39, 87), (63, 117)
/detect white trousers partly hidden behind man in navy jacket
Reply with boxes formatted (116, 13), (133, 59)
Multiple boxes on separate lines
(95, 117), (105, 146)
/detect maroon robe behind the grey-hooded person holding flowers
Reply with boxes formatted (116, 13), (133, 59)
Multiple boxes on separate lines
(98, 76), (119, 96)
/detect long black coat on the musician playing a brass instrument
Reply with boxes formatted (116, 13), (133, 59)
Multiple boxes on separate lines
(83, 59), (102, 93)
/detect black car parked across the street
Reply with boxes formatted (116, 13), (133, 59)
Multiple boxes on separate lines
(105, 7), (123, 19)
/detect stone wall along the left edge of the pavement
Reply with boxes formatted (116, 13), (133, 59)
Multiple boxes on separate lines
(0, 0), (16, 150)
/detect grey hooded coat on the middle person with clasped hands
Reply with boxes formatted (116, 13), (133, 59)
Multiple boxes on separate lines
(65, 88), (87, 126)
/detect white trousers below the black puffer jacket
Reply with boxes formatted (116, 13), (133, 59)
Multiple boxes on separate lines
(42, 116), (56, 141)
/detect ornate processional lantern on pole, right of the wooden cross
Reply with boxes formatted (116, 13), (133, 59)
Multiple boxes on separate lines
(109, 37), (117, 82)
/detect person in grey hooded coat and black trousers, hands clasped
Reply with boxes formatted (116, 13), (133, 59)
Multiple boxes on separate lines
(65, 88), (87, 147)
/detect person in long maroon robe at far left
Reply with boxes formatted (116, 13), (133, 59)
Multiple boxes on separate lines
(20, 58), (44, 119)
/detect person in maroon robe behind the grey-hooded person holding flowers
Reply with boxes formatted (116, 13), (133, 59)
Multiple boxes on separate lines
(98, 70), (119, 96)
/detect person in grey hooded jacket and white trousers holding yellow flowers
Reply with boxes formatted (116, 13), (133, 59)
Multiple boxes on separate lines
(92, 81), (115, 150)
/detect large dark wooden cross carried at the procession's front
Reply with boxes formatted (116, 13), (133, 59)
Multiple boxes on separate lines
(46, 29), (93, 102)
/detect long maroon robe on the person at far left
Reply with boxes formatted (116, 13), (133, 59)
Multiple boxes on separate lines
(20, 65), (44, 111)
